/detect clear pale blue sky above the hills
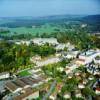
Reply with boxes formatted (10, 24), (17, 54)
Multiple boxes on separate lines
(0, 0), (100, 17)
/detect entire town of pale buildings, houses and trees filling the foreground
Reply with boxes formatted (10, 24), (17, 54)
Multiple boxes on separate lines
(0, 38), (100, 100)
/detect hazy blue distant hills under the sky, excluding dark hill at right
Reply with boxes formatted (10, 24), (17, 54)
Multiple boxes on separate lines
(0, 15), (83, 28)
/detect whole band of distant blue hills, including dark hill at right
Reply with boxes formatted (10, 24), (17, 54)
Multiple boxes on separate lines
(0, 15), (100, 32)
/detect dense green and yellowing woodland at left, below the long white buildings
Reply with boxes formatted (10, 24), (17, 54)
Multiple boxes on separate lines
(0, 41), (55, 72)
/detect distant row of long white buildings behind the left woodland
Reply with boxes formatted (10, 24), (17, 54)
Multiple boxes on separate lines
(13, 38), (74, 50)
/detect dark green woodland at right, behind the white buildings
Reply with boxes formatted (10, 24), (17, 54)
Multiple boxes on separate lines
(41, 28), (100, 49)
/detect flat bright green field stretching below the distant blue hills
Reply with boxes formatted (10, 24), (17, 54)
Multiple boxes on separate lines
(1, 24), (67, 37)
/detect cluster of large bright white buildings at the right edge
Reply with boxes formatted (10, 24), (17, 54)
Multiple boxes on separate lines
(65, 50), (100, 75)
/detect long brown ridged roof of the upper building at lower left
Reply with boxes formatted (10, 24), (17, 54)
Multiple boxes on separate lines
(5, 77), (46, 92)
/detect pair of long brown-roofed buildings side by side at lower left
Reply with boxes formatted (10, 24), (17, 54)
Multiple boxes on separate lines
(3, 75), (50, 100)
